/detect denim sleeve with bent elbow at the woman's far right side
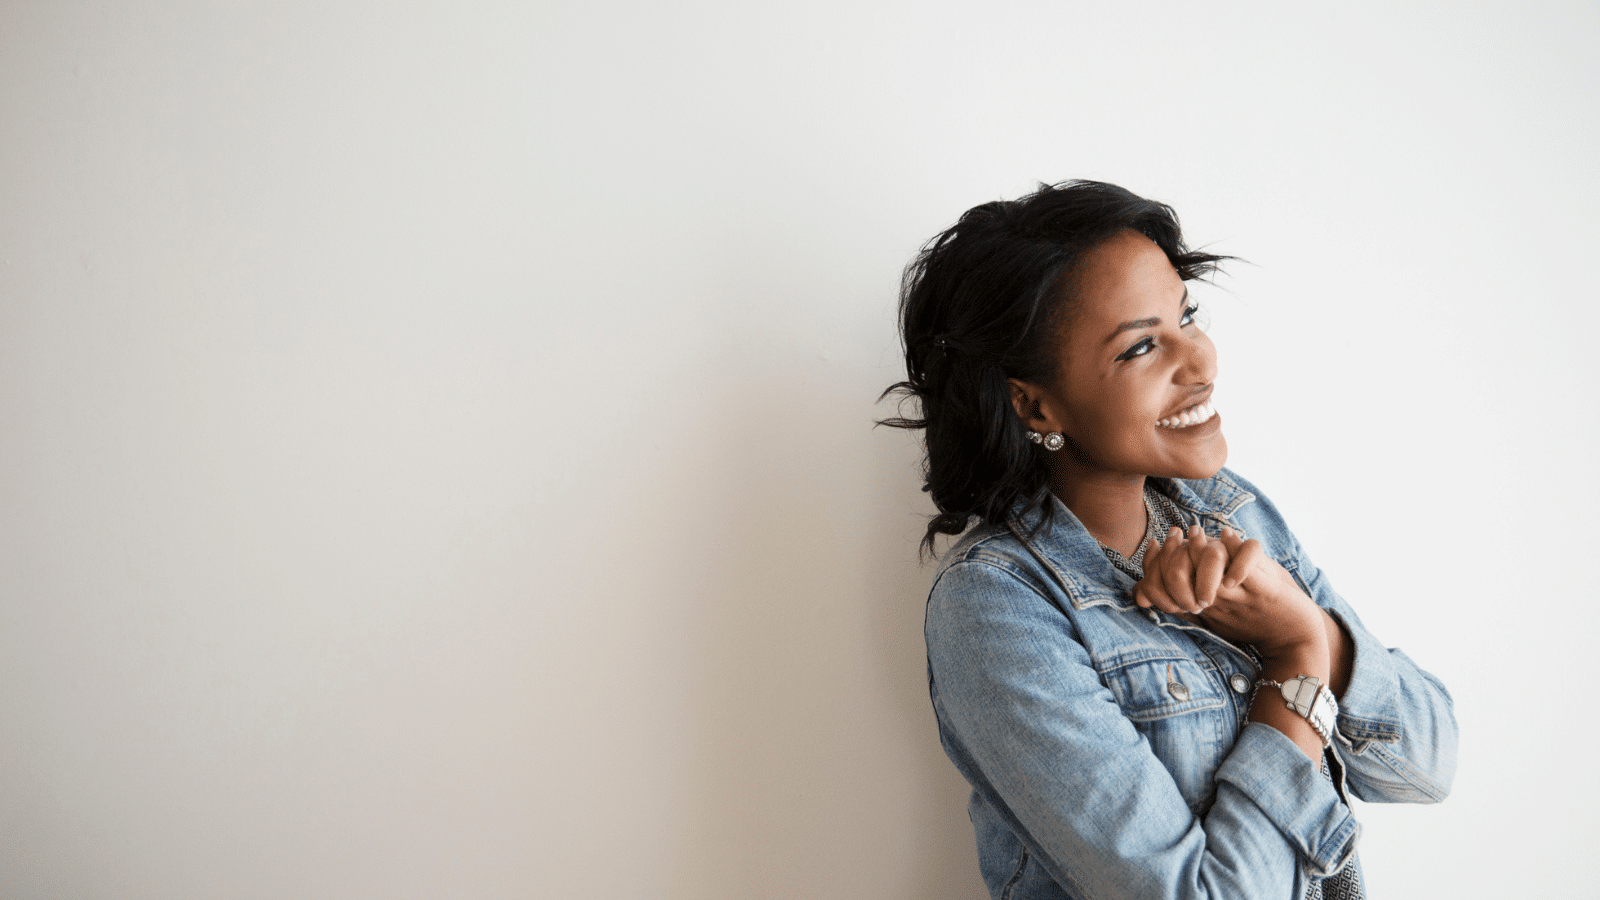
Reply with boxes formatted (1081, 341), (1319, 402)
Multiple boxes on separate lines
(1294, 541), (1456, 802)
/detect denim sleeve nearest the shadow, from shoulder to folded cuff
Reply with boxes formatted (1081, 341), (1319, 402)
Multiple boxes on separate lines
(926, 560), (1360, 900)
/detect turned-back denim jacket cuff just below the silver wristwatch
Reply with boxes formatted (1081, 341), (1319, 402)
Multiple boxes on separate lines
(1216, 722), (1362, 876)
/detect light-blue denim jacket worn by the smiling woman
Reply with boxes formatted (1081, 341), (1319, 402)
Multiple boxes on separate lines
(926, 469), (1456, 900)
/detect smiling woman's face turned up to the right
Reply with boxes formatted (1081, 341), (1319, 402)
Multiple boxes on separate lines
(1018, 231), (1227, 479)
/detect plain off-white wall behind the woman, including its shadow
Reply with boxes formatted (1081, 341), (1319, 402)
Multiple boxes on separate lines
(0, 0), (1600, 900)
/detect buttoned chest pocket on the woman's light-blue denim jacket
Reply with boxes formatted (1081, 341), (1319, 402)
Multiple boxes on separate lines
(1101, 655), (1237, 815)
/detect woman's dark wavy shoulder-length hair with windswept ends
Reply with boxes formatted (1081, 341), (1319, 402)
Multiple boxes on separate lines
(880, 181), (1229, 552)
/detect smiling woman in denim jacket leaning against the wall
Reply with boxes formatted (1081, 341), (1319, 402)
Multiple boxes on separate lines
(890, 181), (1456, 900)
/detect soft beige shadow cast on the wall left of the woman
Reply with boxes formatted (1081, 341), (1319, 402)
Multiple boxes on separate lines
(662, 354), (982, 898)
